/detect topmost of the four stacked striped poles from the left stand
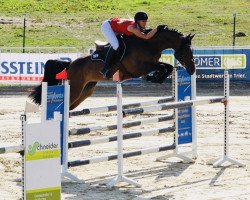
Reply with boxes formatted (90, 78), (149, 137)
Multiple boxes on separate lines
(69, 97), (174, 117)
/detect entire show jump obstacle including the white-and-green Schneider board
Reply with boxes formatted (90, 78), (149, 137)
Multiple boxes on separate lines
(0, 65), (245, 200)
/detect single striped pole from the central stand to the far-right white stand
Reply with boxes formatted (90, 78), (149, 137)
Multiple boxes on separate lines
(123, 97), (226, 116)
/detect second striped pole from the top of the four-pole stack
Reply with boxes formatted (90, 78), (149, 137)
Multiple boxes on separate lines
(69, 115), (174, 135)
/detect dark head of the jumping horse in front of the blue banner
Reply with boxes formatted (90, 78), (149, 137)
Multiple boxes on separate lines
(174, 34), (195, 75)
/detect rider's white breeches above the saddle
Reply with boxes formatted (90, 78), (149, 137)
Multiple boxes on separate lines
(101, 20), (119, 50)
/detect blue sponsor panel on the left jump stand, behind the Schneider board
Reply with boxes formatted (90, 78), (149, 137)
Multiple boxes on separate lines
(46, 85), (64, 163)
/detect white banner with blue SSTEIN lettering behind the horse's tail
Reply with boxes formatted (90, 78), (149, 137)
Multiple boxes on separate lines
(0, 53), (79, 84)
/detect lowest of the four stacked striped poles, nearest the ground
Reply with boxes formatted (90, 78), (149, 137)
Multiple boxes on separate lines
(68, 144), (175, 167)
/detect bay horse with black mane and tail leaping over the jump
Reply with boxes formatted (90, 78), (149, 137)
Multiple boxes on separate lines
(29, 27), (195, 110)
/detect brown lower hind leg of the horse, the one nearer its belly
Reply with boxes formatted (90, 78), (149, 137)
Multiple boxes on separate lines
(70, 82), (97, 110)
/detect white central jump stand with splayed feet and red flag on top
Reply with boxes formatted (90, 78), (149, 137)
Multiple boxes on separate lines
(106, 70), (141, 188)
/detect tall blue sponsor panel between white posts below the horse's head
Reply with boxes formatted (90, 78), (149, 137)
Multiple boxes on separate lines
(177, 68), (192, 144)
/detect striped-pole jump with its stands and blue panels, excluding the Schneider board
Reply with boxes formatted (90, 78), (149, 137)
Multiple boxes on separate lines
(42, 67), (244, 187)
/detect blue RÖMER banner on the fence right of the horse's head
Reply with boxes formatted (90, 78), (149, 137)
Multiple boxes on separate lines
(194, 47), (250, 81)
